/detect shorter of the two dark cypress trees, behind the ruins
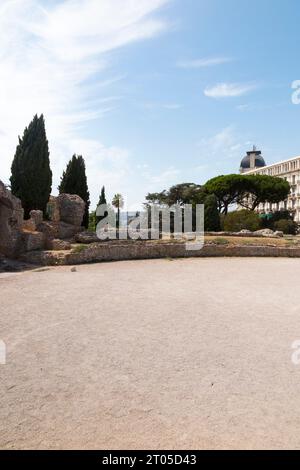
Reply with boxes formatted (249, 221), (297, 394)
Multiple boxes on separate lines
(58, 155), (90, 228)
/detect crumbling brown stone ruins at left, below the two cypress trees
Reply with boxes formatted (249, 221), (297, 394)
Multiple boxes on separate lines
(0, 181), (85, 258)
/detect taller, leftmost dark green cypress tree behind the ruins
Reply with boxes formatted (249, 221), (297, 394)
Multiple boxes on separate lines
(10, 115), (52, 219)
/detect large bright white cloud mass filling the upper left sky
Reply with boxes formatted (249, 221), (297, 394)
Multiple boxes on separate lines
(0, 0), (169, 206)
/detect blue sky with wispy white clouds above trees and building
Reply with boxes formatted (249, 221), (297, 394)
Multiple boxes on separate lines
(0, 0), (300, 209)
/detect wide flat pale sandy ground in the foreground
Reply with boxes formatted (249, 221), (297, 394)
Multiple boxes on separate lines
(0, 258), (300, 449)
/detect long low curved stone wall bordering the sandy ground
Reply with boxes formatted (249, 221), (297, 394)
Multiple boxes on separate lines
(23, 242), (300, 266)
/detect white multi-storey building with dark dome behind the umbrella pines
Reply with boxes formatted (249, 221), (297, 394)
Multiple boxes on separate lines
(240, 148), (300, 224)
